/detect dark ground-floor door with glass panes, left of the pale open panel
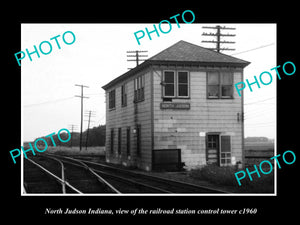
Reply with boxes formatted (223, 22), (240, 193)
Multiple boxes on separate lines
(206, 134), (220, 165)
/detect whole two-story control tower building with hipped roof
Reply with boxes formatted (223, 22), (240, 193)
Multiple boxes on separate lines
(102, 41), (249, 170)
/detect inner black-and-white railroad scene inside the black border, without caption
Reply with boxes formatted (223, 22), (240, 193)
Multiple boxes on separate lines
(19, 22), (276, 195)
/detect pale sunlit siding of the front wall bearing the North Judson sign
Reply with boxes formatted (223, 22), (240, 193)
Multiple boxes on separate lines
(153, 67), (242, 168)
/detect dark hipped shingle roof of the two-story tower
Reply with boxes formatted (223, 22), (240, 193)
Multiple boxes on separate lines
(102, 40), (250, 90)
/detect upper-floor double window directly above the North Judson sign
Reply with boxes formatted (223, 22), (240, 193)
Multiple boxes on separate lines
(163, 71), (189, 98)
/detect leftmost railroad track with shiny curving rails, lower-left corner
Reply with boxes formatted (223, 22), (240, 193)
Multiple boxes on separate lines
(24, 155), (120, 194)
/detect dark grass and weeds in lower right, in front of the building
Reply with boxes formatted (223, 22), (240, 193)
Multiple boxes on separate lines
(188, 165), (274, 193)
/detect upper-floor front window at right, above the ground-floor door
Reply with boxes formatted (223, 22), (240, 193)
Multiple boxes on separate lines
(207, 71), (233, 98)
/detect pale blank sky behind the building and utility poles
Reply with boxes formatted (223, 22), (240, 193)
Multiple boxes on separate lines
(21, 21), (277, 141)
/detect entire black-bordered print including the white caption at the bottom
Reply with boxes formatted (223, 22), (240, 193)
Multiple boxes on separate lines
(2, 5), (299, 220)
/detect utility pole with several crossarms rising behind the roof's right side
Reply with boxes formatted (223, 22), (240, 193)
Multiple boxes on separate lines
(202, 25), (235, 52)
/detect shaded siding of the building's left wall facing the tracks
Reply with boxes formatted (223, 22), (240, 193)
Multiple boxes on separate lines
(106, 71), (151, 170)
